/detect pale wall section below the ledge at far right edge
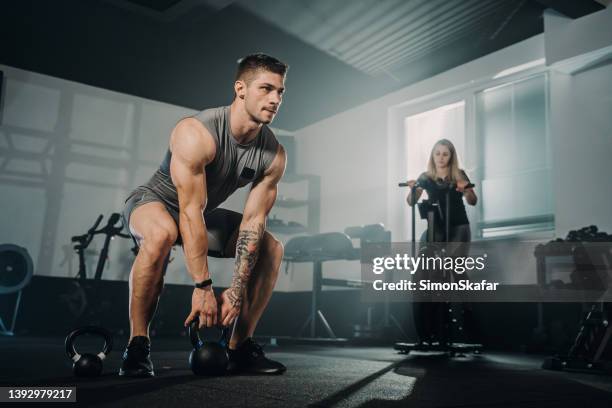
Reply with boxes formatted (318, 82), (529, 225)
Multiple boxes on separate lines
(550, 64), (612, 236)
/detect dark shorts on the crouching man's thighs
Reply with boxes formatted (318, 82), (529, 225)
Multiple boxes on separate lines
(123, 187), (242, 258)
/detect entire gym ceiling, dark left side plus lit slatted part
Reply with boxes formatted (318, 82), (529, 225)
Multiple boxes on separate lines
(0, 0), (604, 130)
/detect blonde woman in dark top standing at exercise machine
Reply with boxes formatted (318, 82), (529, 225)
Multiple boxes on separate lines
(406, 139), (478, 242)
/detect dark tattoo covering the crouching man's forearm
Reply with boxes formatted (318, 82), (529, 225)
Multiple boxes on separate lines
(228, 224), (264, 307)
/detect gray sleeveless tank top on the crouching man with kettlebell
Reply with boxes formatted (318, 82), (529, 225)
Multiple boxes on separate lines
(149, 106), (278, 212)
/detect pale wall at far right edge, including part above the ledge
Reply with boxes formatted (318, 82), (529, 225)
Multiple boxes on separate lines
(544, 7), (612, 236)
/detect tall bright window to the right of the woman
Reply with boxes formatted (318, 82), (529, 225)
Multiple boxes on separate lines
(476, 74), (554, 238)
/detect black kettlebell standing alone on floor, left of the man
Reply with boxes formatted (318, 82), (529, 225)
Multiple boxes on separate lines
(65, 326), (113, 377)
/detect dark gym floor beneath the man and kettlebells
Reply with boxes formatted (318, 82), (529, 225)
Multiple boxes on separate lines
(0, 337), (612, 408)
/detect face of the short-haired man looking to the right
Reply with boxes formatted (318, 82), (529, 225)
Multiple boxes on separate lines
(243, 71), (285, 125)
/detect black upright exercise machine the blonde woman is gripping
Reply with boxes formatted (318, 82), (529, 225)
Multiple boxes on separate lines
(394, 183), (482, 357)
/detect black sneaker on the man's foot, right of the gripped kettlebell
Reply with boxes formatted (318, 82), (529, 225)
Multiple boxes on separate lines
(227, 337), (287, 374)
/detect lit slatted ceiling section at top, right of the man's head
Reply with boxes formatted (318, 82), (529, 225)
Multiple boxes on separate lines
(240, 0), (524, 77)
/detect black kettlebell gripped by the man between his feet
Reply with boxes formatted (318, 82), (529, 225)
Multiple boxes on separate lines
(189, 317), (229, 376)
